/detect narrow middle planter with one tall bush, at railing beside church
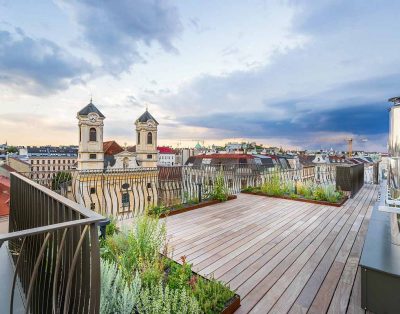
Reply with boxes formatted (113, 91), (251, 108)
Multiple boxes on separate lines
(148, 173), (237, 218)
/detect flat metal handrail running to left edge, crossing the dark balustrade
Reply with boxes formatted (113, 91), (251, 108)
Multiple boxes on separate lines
(0, 214), (105, 247)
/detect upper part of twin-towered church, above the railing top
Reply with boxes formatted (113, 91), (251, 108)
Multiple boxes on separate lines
(77, 101), (158, 171)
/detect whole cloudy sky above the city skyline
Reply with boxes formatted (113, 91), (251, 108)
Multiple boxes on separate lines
(0, 0), (400, 151)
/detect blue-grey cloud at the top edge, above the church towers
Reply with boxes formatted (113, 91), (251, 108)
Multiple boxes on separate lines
(64, 0), (182, 76)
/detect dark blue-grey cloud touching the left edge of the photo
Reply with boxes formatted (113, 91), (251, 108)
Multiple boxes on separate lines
(0, 29), (92, 94)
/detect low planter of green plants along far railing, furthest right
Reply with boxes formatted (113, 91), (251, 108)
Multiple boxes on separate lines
(242, 177), (348, 207)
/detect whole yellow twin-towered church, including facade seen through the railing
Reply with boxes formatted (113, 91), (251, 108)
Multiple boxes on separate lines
(62, 101), (158, 219)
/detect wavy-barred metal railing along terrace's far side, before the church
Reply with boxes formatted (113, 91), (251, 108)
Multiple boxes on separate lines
(18, 164), (336, 219)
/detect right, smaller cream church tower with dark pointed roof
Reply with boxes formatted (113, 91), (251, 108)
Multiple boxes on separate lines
(135, 109), (158, 167)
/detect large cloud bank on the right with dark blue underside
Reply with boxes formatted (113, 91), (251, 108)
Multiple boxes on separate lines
(148, 1), (400, 151)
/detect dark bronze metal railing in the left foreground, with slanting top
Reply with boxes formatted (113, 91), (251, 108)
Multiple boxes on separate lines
(0, 173), (104, 313)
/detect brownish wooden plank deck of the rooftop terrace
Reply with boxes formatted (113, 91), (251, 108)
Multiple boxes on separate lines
(167, 185), (378, 313)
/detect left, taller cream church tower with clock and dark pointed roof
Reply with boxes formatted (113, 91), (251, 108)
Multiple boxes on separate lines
(76, 100), (105, 170)
